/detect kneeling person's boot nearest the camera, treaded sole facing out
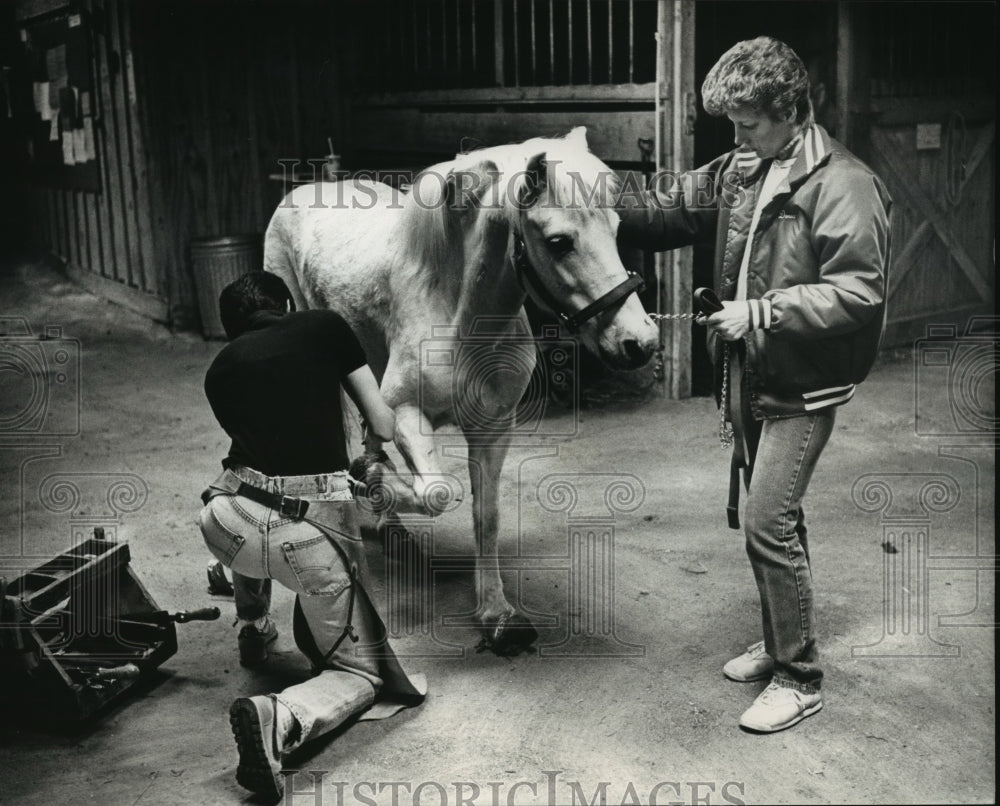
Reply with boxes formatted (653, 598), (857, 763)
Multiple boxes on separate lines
(229, 695), (297, 798)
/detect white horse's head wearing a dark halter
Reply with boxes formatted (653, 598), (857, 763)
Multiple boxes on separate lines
(511, 127), (659, 369)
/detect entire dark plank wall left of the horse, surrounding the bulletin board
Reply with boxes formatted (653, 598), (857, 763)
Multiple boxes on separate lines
(2, 0), (346, 329)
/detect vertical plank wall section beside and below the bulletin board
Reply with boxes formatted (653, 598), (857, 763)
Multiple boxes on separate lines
(21, 0), (168, 321)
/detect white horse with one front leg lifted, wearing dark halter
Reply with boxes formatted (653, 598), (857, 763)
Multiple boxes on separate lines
(264, 127), (658, 654)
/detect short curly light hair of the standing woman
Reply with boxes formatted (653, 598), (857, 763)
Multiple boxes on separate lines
(701, 36), (812, 125)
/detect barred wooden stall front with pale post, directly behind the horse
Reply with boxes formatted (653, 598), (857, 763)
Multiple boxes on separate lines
(338, 0), (694, 397)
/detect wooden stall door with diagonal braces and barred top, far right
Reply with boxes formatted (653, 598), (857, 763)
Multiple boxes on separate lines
(840, 3), (996, 346)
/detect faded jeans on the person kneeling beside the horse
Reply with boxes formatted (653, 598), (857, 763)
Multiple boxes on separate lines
(200, 476), (382, 751)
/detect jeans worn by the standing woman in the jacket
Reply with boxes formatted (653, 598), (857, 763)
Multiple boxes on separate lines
(744, 408), (836, 692)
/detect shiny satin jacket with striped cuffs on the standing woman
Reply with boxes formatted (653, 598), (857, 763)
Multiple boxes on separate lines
(617, 124), (892, 419)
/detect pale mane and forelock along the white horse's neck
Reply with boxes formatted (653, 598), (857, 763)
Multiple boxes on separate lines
(402, 128), (619, 286)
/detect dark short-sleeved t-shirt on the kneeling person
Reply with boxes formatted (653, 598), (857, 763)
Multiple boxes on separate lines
(205, 310), (367, 476)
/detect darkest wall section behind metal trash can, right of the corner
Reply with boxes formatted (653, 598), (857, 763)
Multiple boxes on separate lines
(132, 1), (342, 327)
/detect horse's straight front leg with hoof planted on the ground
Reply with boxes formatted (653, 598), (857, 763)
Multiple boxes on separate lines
(466, 431), (538, 656)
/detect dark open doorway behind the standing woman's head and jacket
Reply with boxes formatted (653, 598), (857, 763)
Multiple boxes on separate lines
(691, 0), (837, 396)
